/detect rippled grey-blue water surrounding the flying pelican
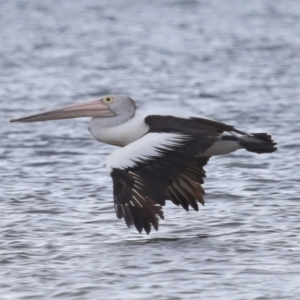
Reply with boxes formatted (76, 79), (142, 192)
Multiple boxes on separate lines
(0, 0), (300, 300)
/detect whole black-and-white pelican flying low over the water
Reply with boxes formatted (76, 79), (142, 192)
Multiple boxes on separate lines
(10, 94), (277, 234)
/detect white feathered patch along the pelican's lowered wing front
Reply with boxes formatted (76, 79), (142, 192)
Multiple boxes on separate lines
(106, 132), (191, 172)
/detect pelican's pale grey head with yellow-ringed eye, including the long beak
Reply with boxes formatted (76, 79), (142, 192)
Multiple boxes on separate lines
(10, 94), (135, 122)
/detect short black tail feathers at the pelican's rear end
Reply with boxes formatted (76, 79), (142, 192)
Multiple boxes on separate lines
(240, 133), (277, 153)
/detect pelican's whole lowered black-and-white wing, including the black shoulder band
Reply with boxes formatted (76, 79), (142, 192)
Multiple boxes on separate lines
(107, 116), (244, 233)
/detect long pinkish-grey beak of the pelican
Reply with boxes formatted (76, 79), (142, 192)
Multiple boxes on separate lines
(10, 100), (115, 122)
